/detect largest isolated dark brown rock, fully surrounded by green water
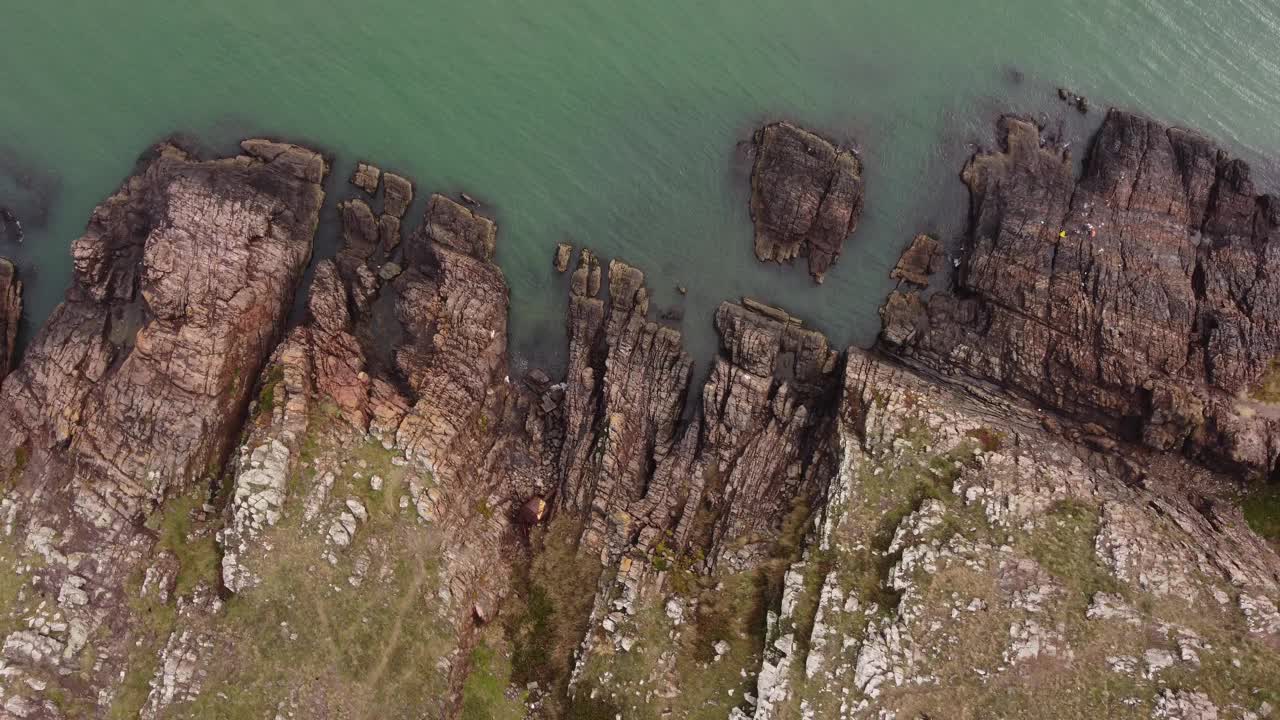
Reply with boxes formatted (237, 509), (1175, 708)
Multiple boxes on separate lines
(751, 123), (863, 282)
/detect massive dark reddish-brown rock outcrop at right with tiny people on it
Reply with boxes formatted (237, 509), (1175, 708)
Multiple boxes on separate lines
(887, 111), (1280, 470)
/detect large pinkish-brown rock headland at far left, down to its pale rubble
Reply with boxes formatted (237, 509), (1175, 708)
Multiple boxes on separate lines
(0, 141), (326, 717)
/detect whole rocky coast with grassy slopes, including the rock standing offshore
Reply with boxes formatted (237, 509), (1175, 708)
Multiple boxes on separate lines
(0, 111), (1280, 720)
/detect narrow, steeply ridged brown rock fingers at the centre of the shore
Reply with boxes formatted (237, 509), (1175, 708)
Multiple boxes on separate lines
(559, 252), (837, 566)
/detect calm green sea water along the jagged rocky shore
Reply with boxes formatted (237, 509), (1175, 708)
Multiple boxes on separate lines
(0, 0), (1280, 369)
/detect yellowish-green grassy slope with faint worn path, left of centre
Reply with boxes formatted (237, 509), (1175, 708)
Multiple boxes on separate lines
(116, 394), (455, 720)
